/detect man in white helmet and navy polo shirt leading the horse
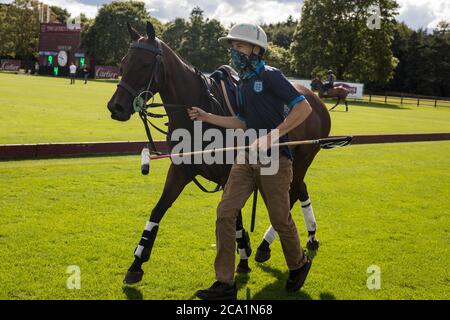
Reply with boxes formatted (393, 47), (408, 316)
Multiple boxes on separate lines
(189, 23), (312, 300)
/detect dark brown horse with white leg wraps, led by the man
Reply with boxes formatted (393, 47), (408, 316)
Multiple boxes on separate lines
(107, 22), (331, 284)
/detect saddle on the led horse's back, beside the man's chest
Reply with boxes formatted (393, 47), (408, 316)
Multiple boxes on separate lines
(209, 65), (239, 116)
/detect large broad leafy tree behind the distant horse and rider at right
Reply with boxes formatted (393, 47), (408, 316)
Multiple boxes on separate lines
(291, 0), (398, 82)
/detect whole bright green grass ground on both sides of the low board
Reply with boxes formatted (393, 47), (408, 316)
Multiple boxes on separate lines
(0, 73), (450, 300)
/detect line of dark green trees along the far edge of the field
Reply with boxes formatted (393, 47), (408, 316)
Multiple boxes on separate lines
(0, 0), (450, 97)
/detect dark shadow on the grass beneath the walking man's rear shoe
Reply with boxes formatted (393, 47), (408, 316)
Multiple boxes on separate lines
(252, 265), (336, 300)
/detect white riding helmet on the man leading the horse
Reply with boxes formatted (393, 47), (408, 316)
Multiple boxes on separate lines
(219, 23), (267, 50)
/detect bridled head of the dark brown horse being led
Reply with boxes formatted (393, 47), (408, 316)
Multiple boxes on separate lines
(108, 22), (162, 121)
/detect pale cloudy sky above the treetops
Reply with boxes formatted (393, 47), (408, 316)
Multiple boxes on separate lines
(0, 0), (450, 29)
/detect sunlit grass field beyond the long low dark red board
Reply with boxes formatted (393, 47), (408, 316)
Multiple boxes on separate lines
(0, 73), (450, 144)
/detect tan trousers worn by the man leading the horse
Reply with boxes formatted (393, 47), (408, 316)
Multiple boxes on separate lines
(214, 155), (306, 282)
